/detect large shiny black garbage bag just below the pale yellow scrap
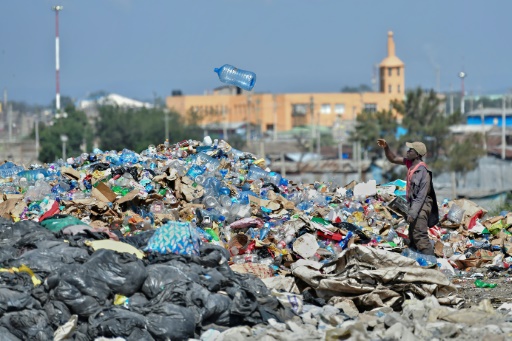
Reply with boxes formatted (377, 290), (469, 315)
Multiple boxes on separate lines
(84, 249), (148, 296)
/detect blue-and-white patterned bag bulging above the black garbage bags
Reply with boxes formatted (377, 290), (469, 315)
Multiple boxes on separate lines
(145, 221), (201, 256)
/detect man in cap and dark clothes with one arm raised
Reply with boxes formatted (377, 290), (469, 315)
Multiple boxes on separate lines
(377, 139), (439, 255)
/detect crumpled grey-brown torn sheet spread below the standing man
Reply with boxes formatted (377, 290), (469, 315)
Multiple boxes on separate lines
(292, 245), (456, 308)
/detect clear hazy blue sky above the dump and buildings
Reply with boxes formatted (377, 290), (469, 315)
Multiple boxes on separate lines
(0, 0), (512, 104)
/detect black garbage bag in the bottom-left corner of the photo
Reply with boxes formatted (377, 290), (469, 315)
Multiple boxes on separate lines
(0, 310), (53, 341)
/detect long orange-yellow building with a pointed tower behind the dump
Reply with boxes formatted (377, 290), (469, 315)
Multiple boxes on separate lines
(166, 32), (405, 137)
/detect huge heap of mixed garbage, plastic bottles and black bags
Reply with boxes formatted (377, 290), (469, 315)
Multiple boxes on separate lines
(0, 137), (512, 340)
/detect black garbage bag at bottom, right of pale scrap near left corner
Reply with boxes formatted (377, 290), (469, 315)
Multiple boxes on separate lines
(88, 307), (147, 338)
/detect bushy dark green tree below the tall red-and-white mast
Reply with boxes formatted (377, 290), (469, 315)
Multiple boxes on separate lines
(31, 105), (93, 162)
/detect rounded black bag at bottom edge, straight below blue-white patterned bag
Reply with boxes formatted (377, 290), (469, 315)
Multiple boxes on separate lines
(146, 302), (196, 341)
